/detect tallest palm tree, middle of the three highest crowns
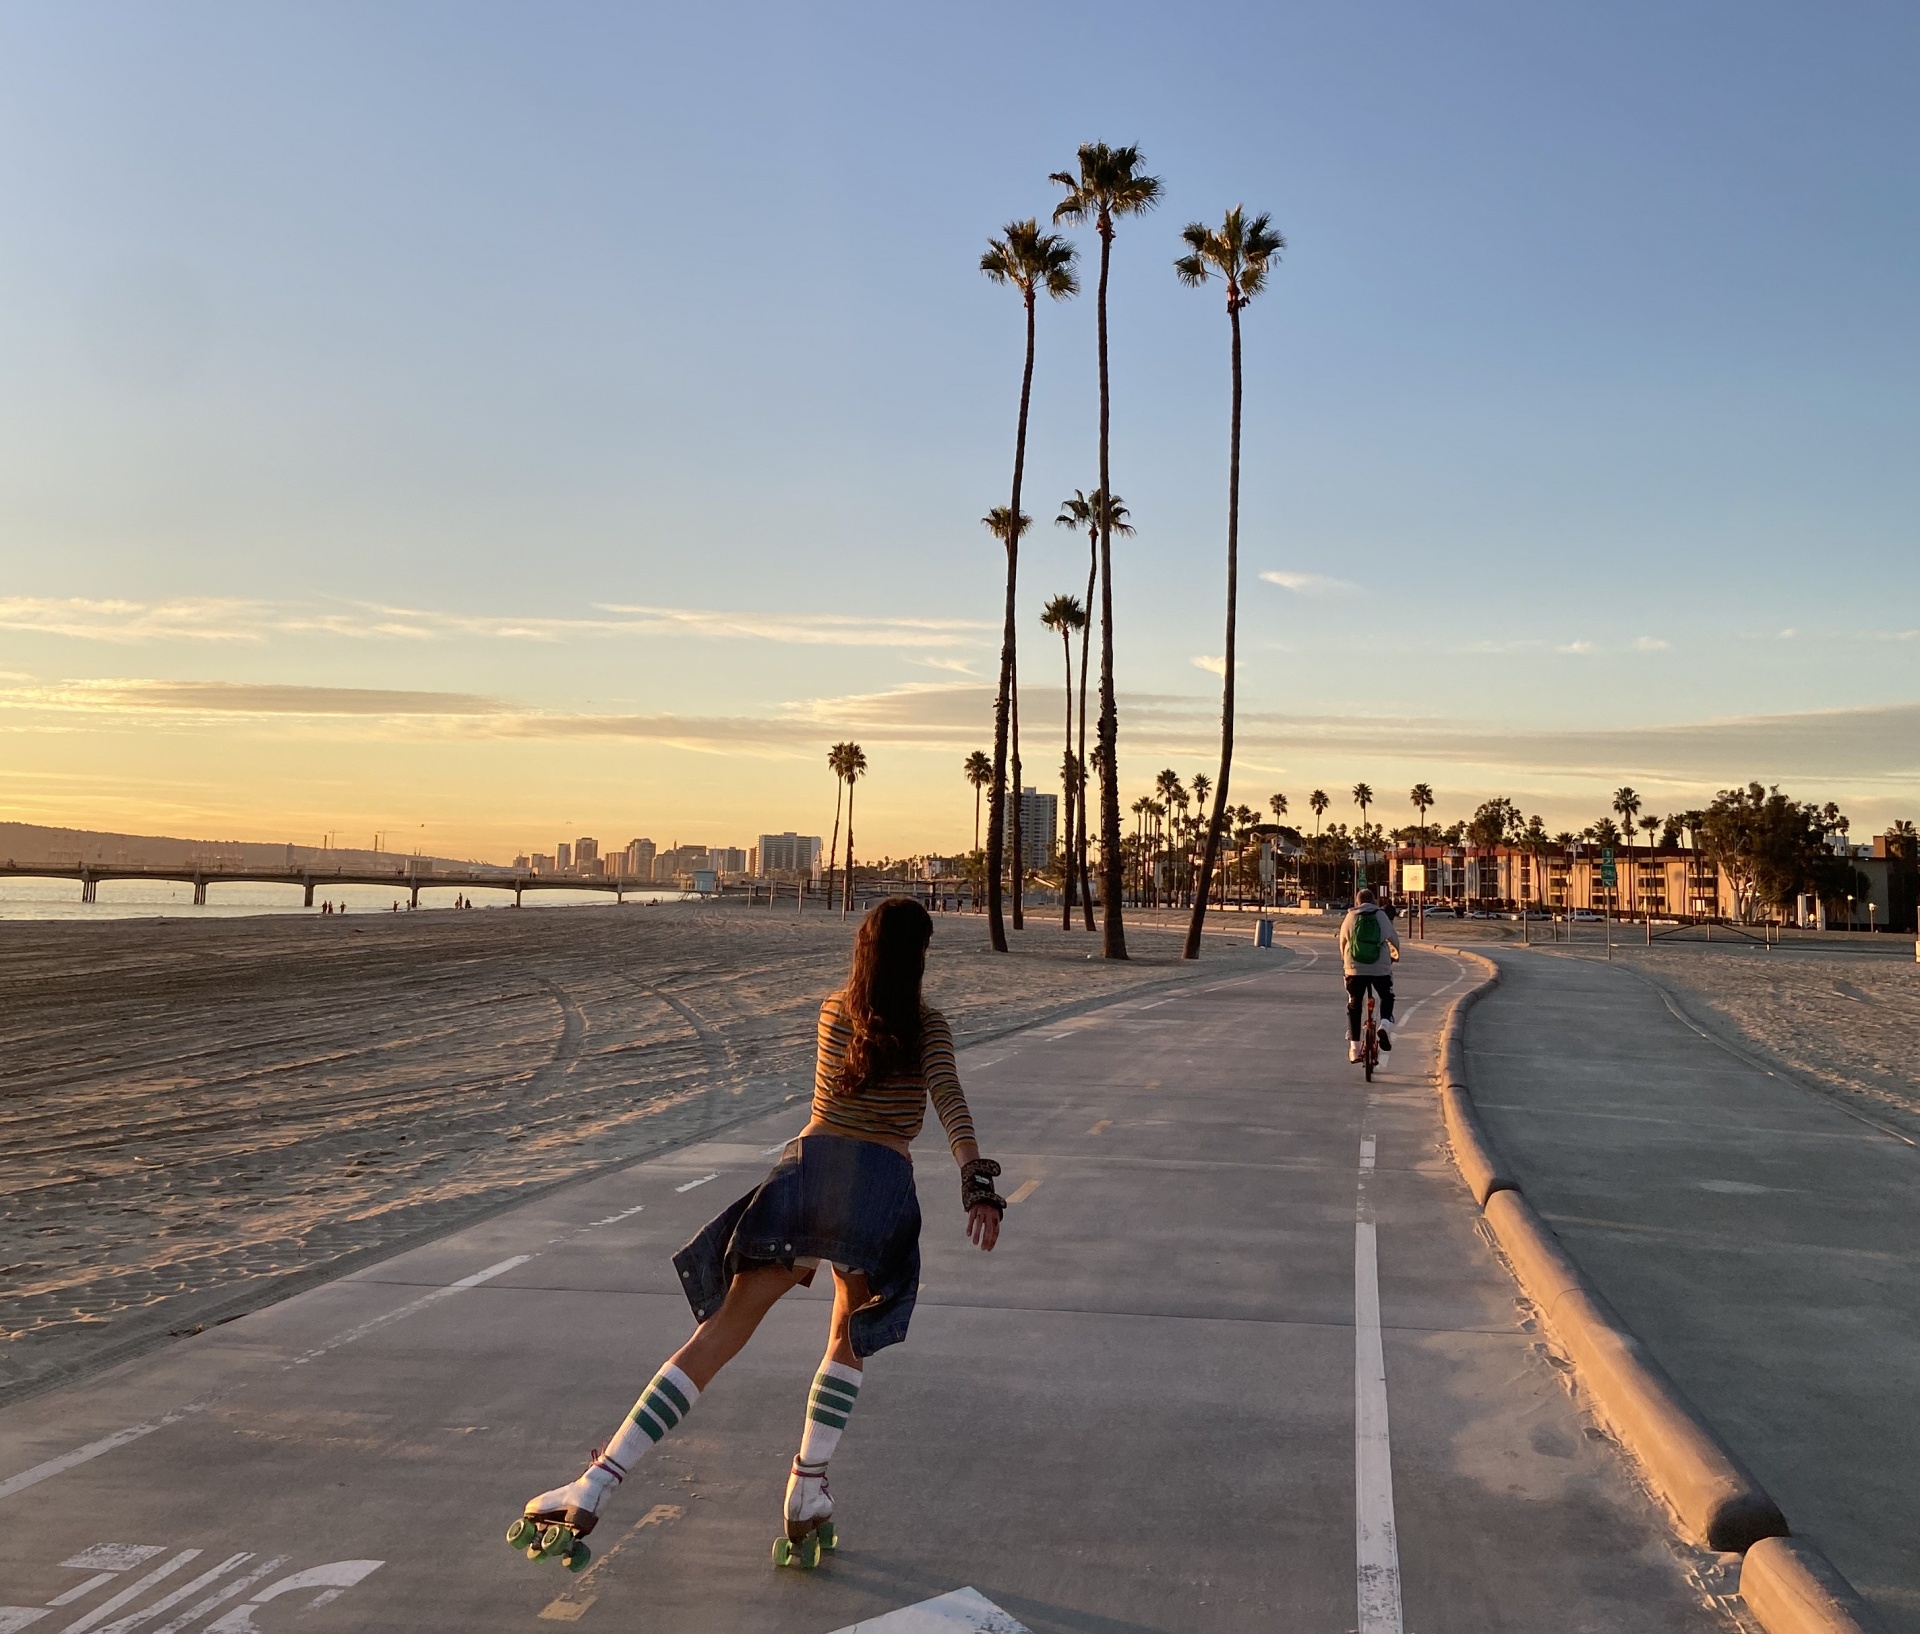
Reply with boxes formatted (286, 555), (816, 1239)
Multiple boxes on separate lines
(1050, 142), (1160, 958)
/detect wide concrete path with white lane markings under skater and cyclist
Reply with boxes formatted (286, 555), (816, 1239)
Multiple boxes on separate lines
(0, 941), (1728, 1634)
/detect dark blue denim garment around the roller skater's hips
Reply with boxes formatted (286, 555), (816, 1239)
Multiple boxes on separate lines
(674, 1135), (920, 1356)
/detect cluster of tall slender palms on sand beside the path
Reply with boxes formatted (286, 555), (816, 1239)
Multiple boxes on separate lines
(975, 142), (1286, 958)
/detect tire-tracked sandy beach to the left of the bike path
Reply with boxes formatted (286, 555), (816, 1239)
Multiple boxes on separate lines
(0, 904), (1261, 1400)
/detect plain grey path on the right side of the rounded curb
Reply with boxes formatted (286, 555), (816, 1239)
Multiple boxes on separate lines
(1467, 949), (1920, 1634)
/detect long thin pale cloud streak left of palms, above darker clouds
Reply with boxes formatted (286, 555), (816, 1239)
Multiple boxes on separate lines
(0, 595), (991, 649)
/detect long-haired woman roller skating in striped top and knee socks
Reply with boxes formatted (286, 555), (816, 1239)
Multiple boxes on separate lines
(507, 897), (1006, 1569)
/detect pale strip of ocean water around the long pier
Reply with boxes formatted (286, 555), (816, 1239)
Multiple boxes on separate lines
(0, 879), (689, 920)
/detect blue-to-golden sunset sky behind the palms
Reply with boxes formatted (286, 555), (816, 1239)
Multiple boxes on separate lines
(0, 0), (1920, 860)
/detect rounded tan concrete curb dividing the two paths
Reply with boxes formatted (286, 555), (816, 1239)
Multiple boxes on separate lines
(1440, 947), (1878, 1634)
